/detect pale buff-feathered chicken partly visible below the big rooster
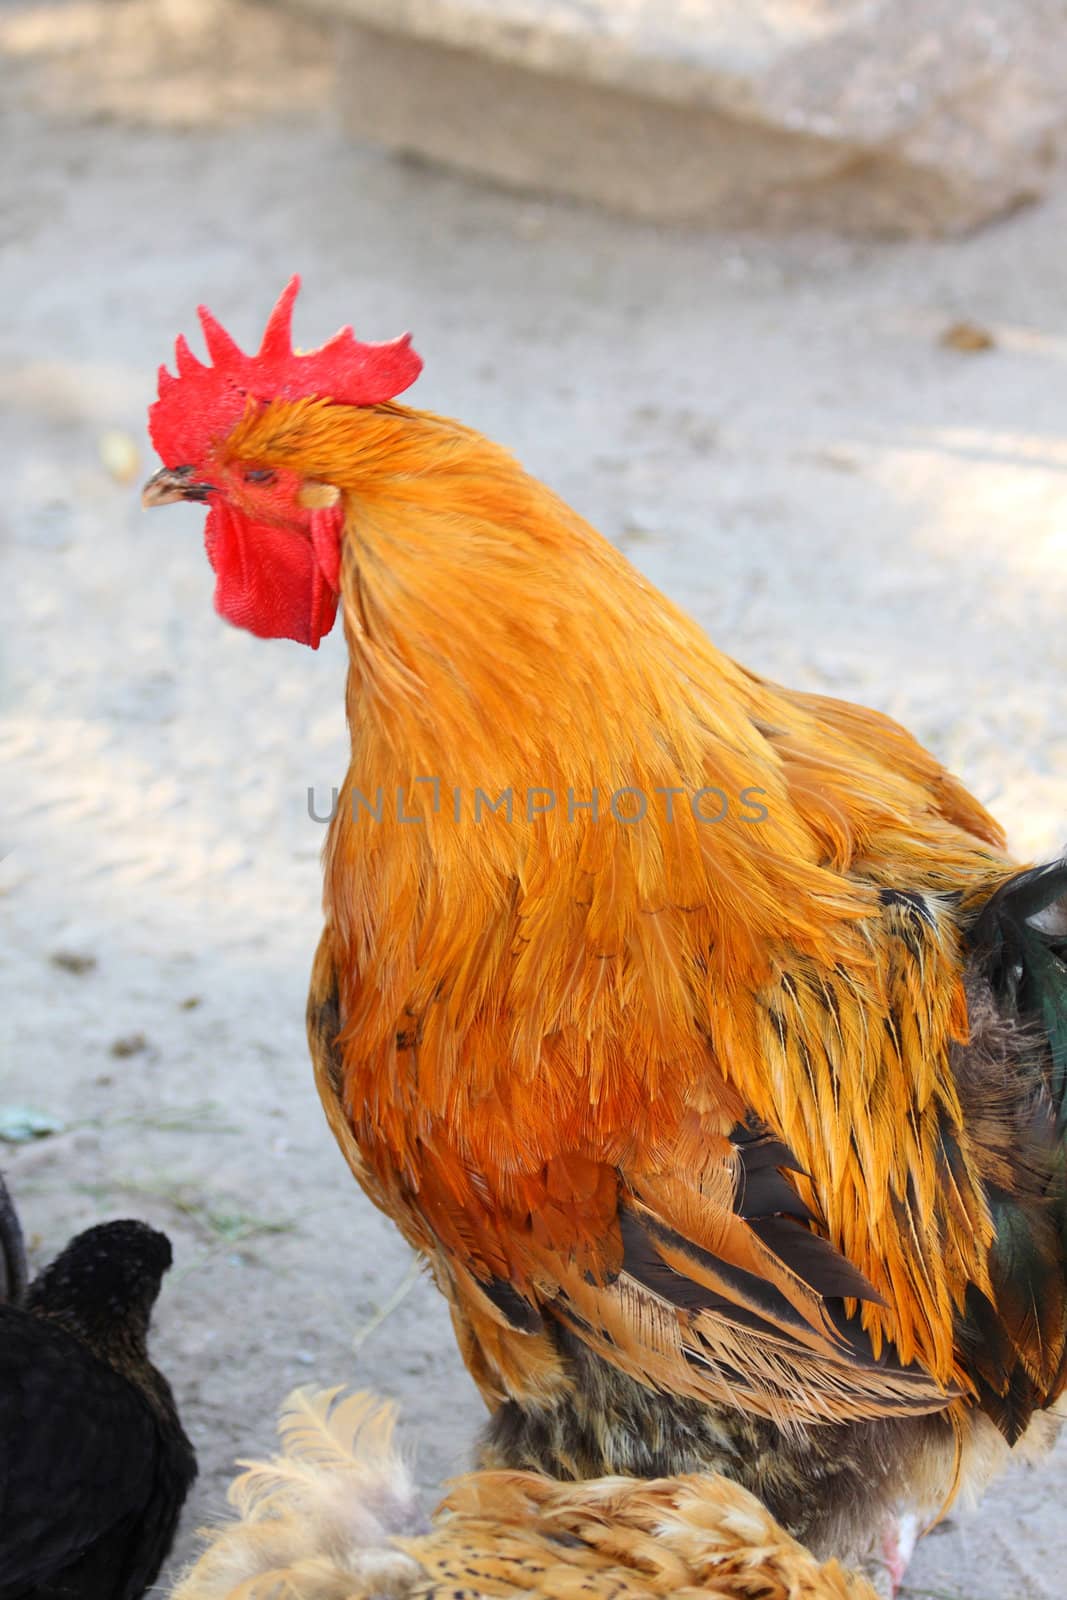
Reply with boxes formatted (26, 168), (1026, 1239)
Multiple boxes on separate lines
(173, 1389), (873, 1600)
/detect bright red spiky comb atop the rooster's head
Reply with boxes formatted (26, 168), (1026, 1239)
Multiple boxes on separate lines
(149, 275), (422, 467)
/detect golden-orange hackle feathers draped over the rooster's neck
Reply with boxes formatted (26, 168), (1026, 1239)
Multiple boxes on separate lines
(310, 406), (992, 1100)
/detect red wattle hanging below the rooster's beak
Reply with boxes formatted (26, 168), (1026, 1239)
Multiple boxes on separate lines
(205, 501), (341, 650)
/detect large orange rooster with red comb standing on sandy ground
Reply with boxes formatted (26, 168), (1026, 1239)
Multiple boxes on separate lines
(144, 278), (1067, 1558)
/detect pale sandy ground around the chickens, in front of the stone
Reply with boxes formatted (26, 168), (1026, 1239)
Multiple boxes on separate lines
(0, 0), (1067, 1600)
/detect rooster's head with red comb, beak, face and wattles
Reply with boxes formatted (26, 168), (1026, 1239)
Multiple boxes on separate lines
(142, 277), (422, 650)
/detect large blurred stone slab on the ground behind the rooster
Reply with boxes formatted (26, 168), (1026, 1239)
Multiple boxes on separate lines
(281, 0), (1067, 234)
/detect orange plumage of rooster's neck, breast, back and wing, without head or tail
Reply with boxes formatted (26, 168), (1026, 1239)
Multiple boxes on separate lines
(227, 402), (1011, 1419)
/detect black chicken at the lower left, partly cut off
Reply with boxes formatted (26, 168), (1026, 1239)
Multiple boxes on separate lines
(0, 1205), (197, 1600)
